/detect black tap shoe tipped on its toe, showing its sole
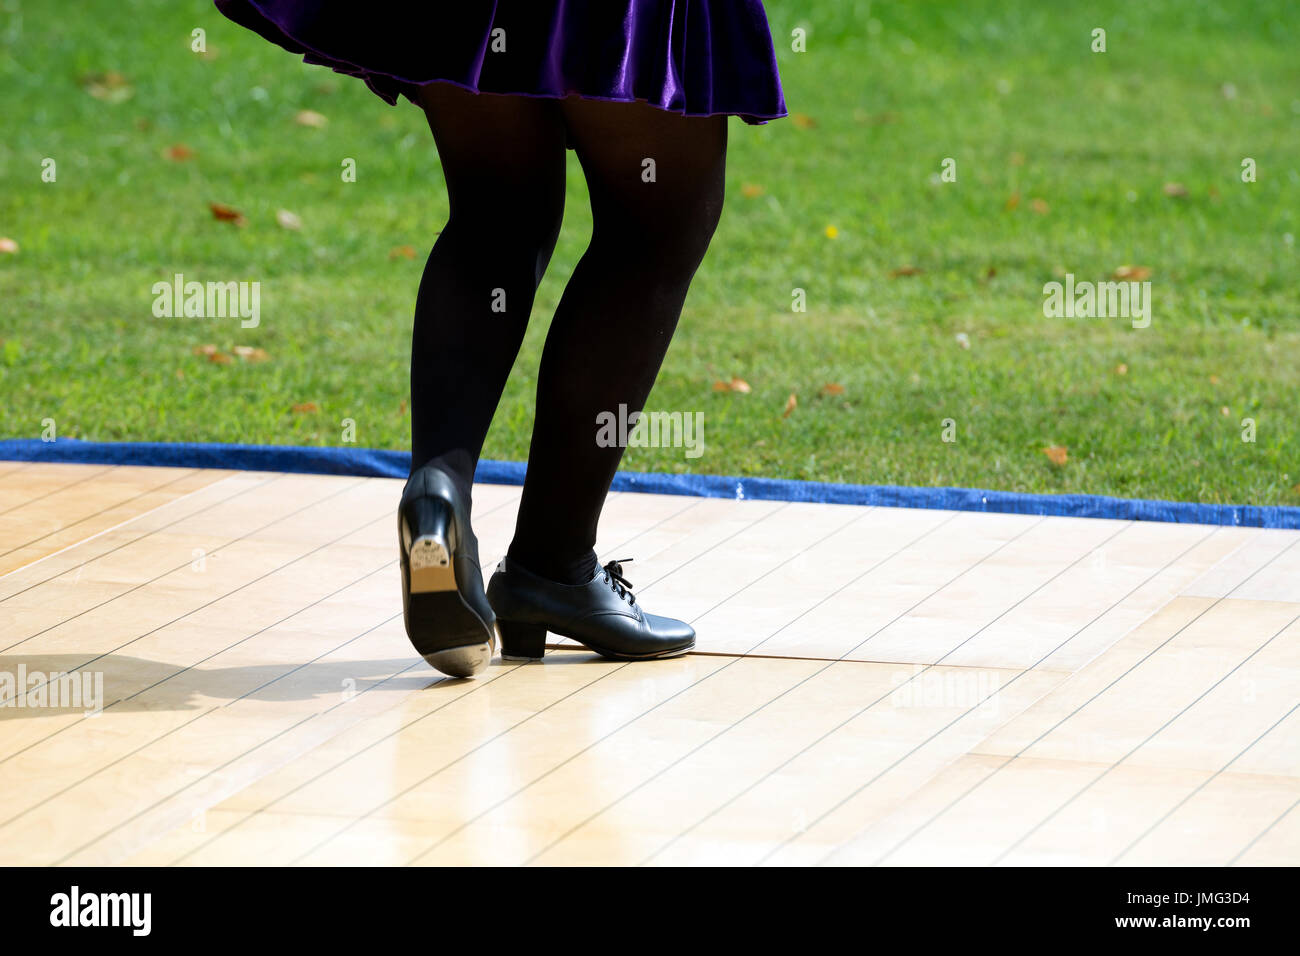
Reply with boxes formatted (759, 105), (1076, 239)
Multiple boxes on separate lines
(398, 464), (497, 678)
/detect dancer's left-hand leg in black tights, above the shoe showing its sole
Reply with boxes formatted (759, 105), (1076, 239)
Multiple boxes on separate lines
(411, 83), (564, 498)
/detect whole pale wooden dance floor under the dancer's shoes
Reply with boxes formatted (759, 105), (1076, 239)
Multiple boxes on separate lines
(0, 462), (1300, 865)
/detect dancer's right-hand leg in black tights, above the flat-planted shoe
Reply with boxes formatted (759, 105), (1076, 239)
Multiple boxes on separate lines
(510, 99), (727, 584)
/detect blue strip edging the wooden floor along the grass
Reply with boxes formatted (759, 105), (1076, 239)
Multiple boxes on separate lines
(0, 438), (1300, 528)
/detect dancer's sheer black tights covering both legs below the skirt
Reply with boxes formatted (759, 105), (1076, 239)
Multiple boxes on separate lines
(411, 83), (727, 584)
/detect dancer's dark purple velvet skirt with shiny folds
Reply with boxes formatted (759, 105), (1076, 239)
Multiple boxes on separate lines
(216, 0), (785, 124)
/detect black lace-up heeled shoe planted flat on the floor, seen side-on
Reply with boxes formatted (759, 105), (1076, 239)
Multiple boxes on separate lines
(488, 558), (696, 661)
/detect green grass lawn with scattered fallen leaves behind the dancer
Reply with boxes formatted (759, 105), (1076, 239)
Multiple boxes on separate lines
(0, 0), (1300, 505)
